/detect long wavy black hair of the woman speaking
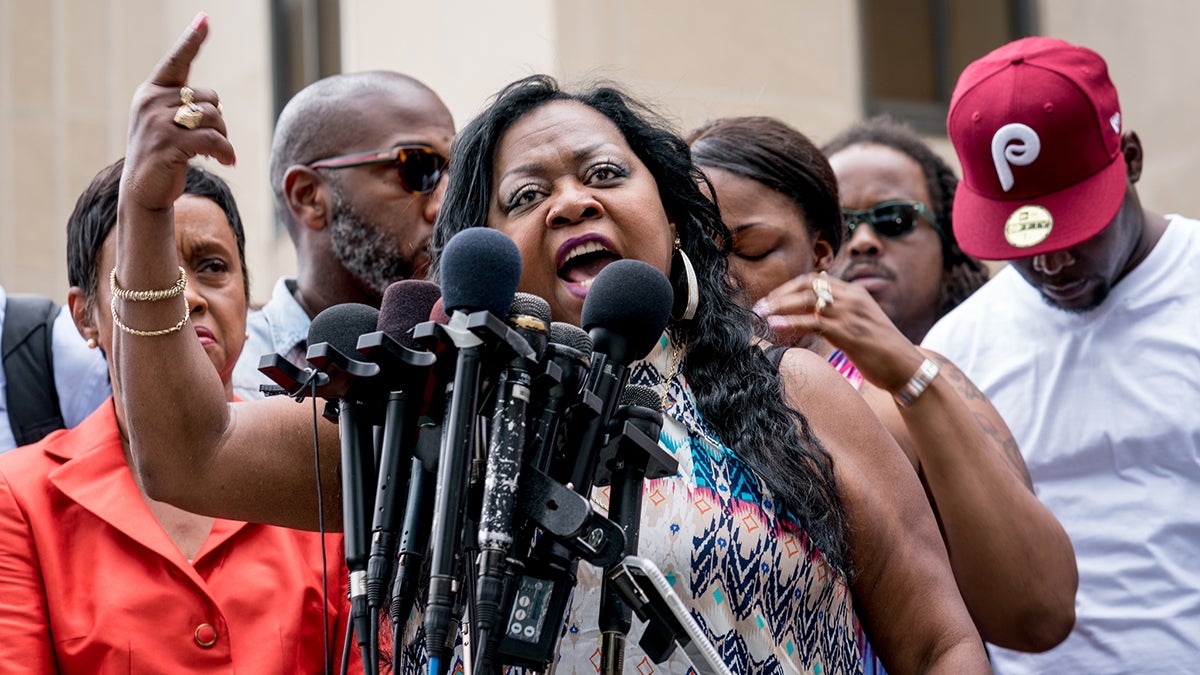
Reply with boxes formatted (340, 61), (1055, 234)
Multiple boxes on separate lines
(430, 76), (851, 572)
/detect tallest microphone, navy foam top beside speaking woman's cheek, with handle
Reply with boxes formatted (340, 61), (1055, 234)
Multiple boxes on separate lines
(425, 227), (528, 675)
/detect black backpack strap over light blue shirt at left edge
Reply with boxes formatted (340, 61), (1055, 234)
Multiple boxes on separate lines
(0, 294), (66, 446)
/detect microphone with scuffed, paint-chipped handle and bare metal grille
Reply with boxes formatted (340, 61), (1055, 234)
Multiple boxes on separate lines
(474, 293), (550, 675)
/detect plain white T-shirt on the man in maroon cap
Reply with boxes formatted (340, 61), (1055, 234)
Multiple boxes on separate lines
(923, 216), (1200, 674)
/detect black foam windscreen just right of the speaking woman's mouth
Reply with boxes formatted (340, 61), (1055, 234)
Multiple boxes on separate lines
(581, 258), (674, 364)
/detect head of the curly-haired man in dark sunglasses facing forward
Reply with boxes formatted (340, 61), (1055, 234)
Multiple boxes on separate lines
(822, 117), (988, 345)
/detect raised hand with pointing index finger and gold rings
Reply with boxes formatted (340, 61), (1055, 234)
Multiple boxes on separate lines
(121, 13), (236, 211)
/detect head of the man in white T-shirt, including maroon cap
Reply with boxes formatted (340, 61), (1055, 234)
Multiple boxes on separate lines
(947, 37), (1165, 311)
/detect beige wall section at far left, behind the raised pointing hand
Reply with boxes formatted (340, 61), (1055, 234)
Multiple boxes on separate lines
(0, 0), (274, 301)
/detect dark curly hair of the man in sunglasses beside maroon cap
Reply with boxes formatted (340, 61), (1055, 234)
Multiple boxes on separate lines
(821, 115), (988, 318)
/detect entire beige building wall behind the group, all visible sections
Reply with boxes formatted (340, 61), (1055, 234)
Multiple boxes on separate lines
(0, 0), (1200, 301)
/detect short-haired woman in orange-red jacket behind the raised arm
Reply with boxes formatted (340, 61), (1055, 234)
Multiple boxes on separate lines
(0, 161), (347, 674)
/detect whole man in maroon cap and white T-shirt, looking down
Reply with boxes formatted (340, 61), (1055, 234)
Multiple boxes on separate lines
(923, 37), (1200, 674)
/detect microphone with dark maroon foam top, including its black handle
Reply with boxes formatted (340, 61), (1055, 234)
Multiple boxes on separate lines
(358, 279), (442, 613)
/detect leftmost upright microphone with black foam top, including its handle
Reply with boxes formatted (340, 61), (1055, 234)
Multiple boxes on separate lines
(307, 303), (379, 668)
